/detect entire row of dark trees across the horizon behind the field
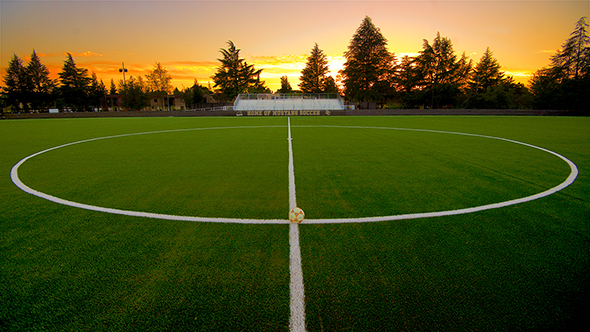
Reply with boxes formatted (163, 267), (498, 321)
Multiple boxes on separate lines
(2, 16), (590, 112)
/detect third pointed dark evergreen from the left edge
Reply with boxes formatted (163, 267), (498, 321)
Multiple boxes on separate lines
(59, 53), (91, 111)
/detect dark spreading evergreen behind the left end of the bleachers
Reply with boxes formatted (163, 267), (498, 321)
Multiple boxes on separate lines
(211, 40), (267, 100)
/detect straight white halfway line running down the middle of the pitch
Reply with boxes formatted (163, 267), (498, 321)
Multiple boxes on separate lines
(287, 118), (305, 332)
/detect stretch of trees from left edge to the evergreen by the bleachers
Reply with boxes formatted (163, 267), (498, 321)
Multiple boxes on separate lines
(0, 50), (215, 112)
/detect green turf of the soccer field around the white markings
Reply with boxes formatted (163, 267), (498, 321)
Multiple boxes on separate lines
(0, 116), (590, 331)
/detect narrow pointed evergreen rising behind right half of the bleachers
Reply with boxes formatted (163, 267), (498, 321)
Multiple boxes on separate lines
(299, 43), (329, 93)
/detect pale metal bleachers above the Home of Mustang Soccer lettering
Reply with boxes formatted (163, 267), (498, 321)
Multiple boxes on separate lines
(233, 93), (345, 111)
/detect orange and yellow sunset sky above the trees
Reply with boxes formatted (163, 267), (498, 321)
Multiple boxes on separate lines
(0, 0), (590, 91)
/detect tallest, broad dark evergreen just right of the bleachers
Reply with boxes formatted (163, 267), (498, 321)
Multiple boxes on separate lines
(340, 16), (395, 101)
